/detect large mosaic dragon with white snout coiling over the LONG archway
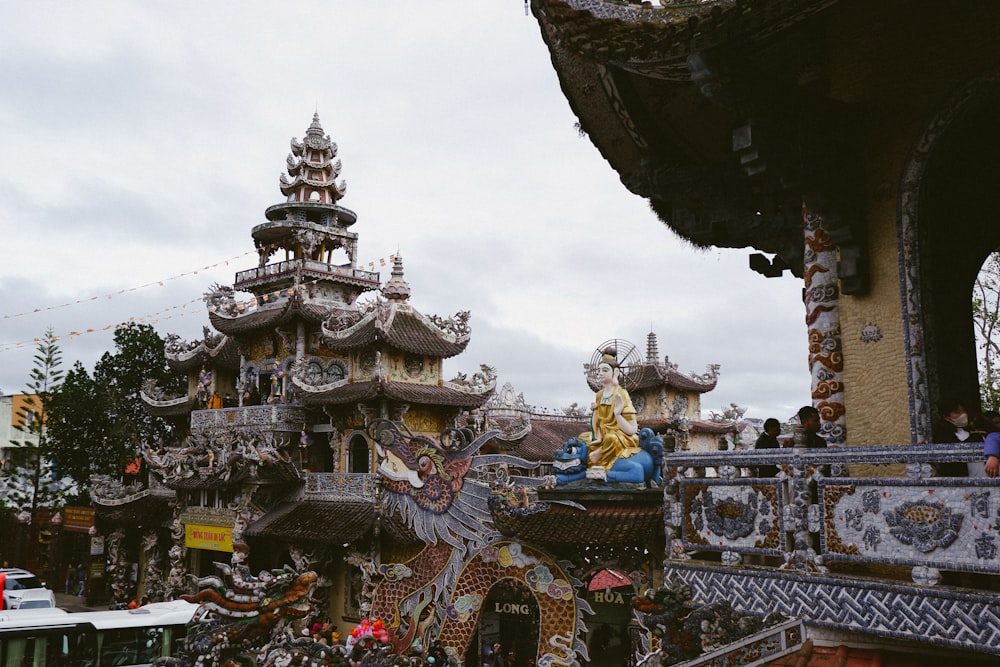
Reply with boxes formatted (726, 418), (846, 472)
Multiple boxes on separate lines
(369, 419), (592, 667)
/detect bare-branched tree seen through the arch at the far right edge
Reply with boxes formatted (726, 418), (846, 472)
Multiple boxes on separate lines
(972, 252), (1000, 410)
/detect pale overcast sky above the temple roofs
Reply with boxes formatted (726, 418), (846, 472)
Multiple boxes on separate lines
(0, 0), (809, 418)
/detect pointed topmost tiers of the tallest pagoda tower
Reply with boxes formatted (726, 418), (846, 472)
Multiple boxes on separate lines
(279, 112), (347, 204)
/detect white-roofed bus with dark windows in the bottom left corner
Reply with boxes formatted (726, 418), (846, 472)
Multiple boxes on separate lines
(0, 600), (198, 667)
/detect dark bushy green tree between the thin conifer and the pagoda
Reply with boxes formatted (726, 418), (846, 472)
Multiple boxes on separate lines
(50, 323), (184, 484)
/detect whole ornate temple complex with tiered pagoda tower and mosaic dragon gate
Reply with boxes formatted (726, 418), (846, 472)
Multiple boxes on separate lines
(84, 112), (733, 665)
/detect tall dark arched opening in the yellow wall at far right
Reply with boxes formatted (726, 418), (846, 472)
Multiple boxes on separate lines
(898, 66), (1000, 442)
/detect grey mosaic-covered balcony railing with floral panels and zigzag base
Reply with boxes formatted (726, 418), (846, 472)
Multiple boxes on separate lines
(663, 444), (1000, 654)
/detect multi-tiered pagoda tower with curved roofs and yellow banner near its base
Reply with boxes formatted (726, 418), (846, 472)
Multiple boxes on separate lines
(95, 115), (495, 615)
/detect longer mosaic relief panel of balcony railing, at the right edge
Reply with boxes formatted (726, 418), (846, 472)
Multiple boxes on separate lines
(819, 479), (1000, 572)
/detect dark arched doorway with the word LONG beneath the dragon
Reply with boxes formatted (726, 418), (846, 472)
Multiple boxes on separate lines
(465, 579), (539, 667)
